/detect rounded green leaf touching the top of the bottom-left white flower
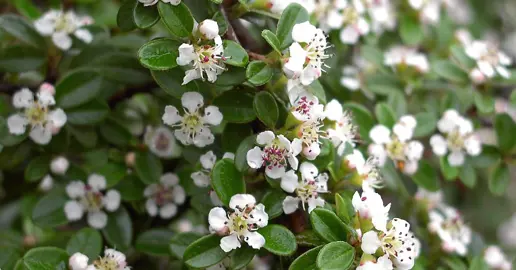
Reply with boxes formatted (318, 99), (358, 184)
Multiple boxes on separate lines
(66, 228), (102, 259)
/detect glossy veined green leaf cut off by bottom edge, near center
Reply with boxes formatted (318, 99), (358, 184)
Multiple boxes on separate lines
(317, 241), (355, 270)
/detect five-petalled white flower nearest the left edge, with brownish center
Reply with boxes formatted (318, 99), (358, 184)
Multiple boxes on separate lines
(7, 88), (66, 144)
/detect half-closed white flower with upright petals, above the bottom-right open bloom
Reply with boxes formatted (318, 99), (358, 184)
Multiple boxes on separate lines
(351, 189), (391, 231)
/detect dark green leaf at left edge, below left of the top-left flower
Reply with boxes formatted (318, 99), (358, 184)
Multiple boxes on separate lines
(0, 45), (47, 73)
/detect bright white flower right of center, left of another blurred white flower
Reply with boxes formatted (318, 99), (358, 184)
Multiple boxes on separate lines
(369, 115), (424, 175)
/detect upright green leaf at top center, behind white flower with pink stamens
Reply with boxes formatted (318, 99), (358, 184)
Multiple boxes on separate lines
(276, 3), (310, 51)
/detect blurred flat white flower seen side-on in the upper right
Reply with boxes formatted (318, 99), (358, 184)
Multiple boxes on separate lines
(384, 46), (430, 73)
